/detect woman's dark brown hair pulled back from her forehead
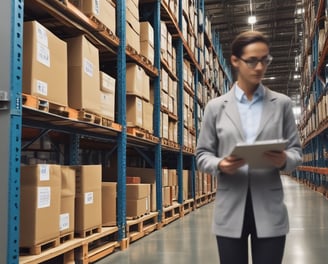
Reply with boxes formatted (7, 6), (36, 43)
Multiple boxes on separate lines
(231, 31), (269, 58)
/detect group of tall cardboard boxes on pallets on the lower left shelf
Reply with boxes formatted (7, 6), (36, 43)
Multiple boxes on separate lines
(20, 164), (104, 254)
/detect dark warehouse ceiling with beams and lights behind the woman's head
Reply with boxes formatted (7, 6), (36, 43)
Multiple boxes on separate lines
(204, 0), (303, 106)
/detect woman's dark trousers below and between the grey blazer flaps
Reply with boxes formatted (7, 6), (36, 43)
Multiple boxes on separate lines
(217, 192), (286, 264)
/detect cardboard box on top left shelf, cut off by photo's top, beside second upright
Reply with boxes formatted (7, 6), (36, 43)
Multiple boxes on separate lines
(70, 0), (116, 34)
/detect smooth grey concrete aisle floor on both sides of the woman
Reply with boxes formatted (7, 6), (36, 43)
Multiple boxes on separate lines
(97, 176), (328, 264)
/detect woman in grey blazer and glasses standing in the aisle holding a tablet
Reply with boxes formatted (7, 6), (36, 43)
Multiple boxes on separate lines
(196, 31), (302, 264)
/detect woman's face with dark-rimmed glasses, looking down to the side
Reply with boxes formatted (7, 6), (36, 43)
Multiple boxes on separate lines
(231, 42), (271, 86)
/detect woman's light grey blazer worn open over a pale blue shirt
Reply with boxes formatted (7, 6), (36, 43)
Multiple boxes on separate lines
(196, 87), (302, 238)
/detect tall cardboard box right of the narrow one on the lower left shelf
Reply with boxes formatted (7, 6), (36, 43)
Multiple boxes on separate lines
(71, 165), (102, 233)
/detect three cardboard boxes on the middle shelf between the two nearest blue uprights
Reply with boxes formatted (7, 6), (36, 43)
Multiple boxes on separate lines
(23, 18), (115, 124)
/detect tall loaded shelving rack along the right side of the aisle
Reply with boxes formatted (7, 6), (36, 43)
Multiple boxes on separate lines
(296, 0), (328, 196)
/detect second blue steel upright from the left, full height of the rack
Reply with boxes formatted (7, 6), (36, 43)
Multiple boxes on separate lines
(116, 0), (127, 241)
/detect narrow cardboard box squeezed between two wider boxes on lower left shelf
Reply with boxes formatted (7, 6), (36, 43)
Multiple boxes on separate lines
(59, 166), (75, 236)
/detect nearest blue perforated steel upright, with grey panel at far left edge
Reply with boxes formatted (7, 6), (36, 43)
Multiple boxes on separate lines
(0, 0), (24, 264)
